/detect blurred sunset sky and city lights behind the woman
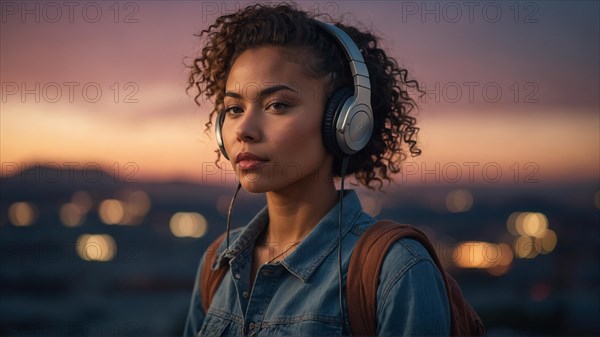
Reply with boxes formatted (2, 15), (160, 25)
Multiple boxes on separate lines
(0, 1), (600, 337)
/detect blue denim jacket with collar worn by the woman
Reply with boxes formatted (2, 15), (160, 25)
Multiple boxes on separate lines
(184, 191), (450, 337)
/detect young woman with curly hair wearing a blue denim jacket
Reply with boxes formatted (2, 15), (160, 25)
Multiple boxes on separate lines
(184, 5), (450, 336)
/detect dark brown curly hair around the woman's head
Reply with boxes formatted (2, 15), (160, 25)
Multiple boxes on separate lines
(187, 4), (423, 189)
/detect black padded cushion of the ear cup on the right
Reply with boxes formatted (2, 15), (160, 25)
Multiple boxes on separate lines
(321, 88), (354, 158)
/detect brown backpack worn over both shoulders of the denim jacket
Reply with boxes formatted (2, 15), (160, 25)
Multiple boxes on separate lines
(199, 220), (485, 336)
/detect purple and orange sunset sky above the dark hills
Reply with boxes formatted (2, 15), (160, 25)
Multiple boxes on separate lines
(0, 1), (600, 182)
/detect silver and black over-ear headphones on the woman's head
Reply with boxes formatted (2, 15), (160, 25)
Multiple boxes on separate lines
(215, 21), (373, 159)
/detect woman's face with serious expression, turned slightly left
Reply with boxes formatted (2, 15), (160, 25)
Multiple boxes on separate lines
(222, 46), (333, 193)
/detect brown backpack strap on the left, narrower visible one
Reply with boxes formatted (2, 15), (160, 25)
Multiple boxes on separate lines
(199, 233), (229, 313)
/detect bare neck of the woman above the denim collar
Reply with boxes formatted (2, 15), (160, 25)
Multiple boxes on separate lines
(265, 182), (338, 246)
